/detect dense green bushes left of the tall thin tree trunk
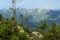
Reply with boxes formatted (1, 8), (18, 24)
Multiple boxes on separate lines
(0, 20), (15, 40)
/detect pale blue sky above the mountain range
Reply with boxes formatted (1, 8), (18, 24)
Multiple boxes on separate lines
(0, 0), (60, 9)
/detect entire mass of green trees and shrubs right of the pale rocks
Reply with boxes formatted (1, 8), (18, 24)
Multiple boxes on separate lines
(36, 21), (60, 40)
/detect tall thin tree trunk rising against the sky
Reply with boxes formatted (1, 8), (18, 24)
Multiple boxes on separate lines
(12, 0), (18, 33)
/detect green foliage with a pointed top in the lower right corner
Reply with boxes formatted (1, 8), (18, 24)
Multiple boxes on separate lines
(44, 22), (60, 40)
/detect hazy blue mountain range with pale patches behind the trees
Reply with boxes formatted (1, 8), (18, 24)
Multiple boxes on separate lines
(0, 8), (60, 27)
